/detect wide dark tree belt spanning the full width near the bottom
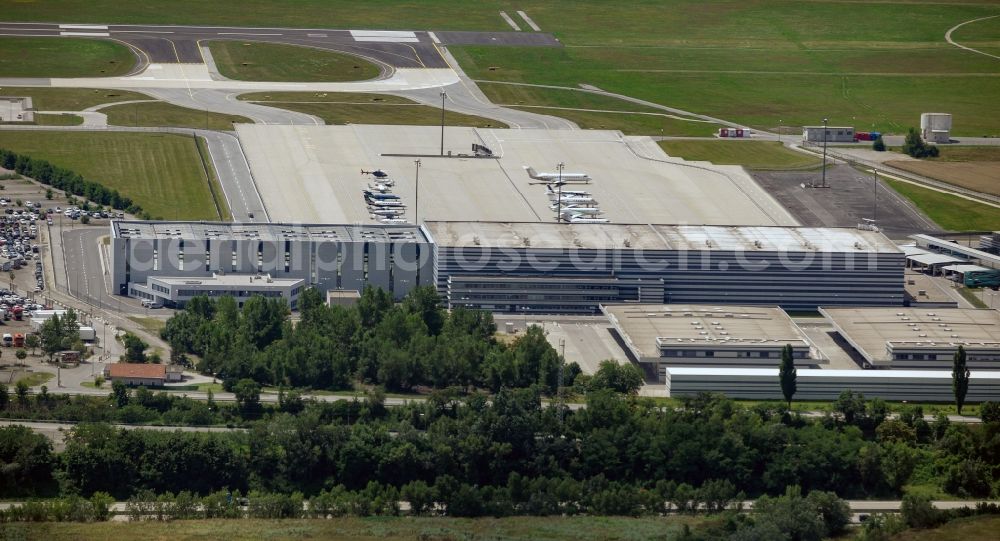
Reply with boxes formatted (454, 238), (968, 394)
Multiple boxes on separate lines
(0, 387), (1000, 504)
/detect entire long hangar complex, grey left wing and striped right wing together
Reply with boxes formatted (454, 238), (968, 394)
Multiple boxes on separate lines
(110, 221), (904, 314)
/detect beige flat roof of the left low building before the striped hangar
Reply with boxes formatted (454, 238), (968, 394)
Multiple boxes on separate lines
(601, 304), (809, 358)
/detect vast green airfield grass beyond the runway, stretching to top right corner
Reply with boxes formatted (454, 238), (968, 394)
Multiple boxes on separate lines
(4, 0), (1000, 136)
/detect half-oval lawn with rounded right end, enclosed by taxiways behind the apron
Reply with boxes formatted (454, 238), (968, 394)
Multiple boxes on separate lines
(208, 41), (381, 82)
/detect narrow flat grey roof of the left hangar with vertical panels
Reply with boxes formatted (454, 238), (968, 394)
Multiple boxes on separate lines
(111, 220), (427, 242)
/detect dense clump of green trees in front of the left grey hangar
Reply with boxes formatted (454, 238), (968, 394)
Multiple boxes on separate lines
(161, 286), (588, 394)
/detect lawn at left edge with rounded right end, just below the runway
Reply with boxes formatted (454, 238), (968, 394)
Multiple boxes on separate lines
(0, 36), (136, 77)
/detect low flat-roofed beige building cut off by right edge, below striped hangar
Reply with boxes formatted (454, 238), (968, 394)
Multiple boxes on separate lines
(820, 307), (1000, 370)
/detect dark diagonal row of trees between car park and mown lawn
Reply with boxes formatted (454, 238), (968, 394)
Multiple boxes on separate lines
(0, 148), (149, 219)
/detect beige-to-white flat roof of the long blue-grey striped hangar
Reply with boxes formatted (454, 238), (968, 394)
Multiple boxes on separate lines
(424, 221), (902, 254)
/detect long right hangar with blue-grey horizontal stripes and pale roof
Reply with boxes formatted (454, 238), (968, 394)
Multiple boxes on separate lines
(424, 221), (905, 314)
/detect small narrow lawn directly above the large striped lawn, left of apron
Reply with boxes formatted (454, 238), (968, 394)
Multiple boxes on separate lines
(101, 102), (253, 131)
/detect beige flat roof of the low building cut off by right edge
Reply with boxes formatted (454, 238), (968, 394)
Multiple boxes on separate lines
(819, 307), (1000, 363)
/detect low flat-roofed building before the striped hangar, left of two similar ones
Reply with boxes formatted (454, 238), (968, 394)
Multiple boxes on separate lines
(601, 304), (818, 381)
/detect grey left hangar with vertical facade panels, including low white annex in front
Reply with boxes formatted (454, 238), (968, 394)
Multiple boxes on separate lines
(110, 221), (434, 303)
